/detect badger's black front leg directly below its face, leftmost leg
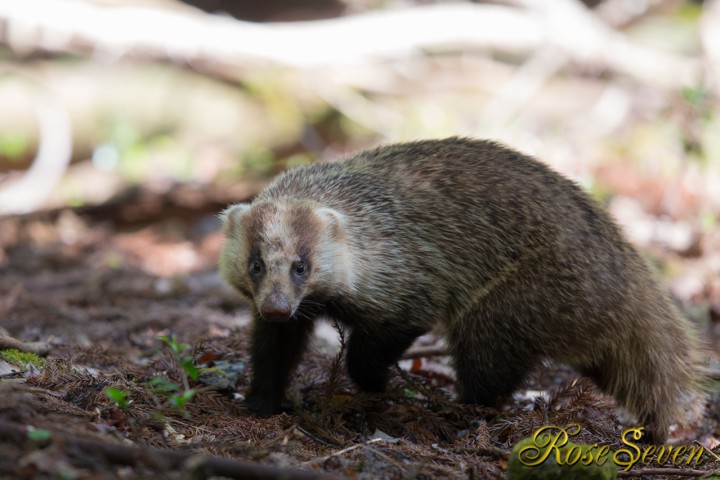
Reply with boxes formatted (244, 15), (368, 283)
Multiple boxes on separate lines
(245, 313), (313, 417)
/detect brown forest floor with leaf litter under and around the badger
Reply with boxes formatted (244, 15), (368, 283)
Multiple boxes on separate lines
(0, 182), (720, 479)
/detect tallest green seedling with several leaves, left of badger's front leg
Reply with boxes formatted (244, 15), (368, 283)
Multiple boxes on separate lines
(150, 335), (198, 414)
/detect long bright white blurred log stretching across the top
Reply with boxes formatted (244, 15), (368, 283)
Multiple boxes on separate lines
(0, 0), (700, 88)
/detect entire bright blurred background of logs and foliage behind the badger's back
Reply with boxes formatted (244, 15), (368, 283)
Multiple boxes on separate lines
(0, 0), (720, 315)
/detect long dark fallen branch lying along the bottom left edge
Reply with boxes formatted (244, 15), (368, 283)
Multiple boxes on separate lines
(0, 420), (344, 480)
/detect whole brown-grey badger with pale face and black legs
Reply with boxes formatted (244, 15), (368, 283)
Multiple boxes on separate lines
(220, 138), (697, 441)
